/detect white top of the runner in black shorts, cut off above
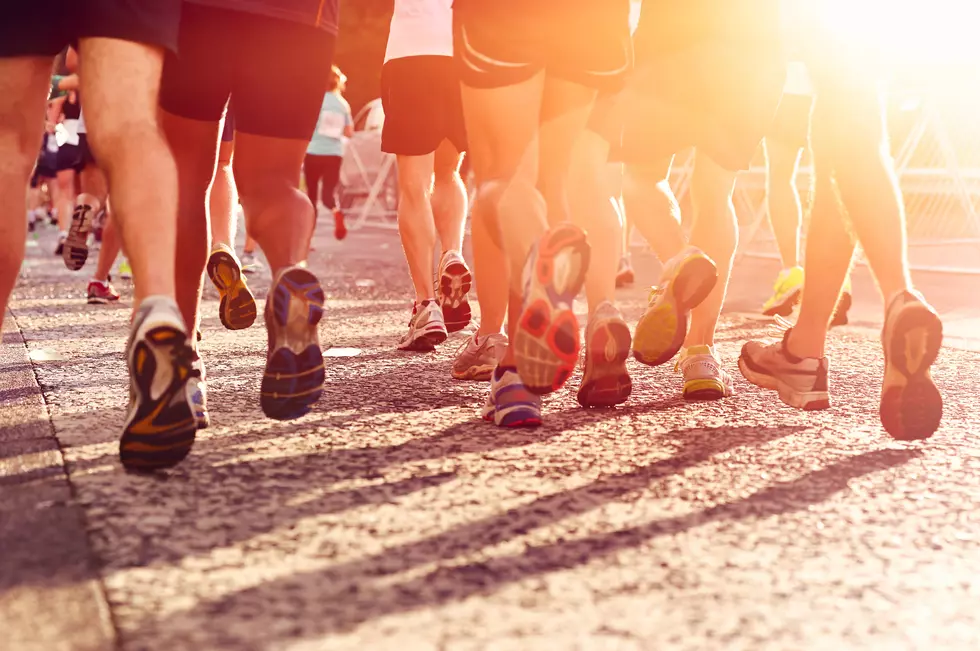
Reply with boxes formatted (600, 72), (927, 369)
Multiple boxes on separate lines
(385, 0), (456, 63)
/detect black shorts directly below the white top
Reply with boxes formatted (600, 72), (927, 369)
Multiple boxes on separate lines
(381, 56), (466, 156)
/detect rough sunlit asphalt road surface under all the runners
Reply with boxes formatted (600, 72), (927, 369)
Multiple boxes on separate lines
(0, 222), (980, 651)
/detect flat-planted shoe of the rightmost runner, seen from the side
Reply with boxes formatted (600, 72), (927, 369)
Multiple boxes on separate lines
(738, 329), (830, 411)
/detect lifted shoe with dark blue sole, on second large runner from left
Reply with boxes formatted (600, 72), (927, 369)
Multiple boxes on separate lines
(261, 266), (325, 420)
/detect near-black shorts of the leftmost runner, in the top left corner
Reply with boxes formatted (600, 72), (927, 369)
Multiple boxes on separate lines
(0, 0), (183, 58)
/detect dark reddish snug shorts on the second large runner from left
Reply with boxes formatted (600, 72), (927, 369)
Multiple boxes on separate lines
(160, 3), (336, 141)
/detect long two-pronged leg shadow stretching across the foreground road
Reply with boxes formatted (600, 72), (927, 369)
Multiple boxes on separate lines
(117, 420), (921, 650)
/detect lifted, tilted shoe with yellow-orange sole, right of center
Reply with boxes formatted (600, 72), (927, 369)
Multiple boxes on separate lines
(633, 246), (718, 366)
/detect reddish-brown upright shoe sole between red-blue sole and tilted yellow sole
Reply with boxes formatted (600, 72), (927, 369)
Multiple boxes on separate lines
(578, 301), (633, 407)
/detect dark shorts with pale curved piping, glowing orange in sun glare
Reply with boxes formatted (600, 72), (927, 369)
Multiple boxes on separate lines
(453, 0), (633, 90)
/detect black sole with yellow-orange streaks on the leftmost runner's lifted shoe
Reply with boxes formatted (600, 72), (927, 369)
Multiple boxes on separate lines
(119, 326), (198, 472)
